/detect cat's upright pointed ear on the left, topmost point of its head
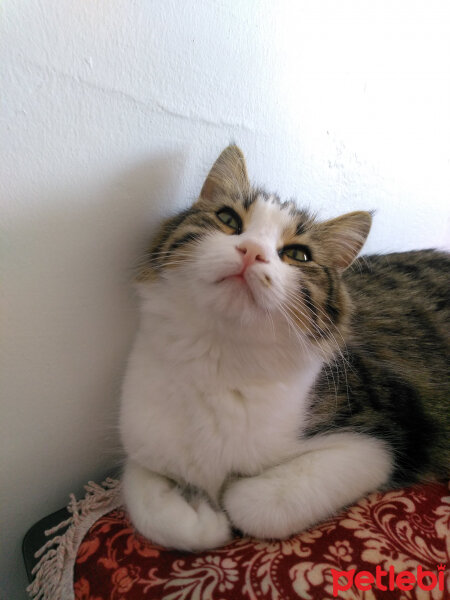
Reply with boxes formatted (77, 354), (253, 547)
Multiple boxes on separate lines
(200, 145), (250, 200)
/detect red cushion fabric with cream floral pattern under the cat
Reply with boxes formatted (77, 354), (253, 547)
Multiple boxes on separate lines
(75, 484), (450, 600)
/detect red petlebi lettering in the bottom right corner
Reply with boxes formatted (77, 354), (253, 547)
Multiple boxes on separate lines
(331, 565), (446, 597)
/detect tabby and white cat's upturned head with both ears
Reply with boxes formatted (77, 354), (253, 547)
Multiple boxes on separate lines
(139, 146), (371, 340)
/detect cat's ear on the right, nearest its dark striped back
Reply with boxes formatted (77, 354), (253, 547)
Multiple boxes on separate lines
(314, 211), (372, 271)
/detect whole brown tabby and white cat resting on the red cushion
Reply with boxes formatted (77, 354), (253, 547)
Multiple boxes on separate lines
(120, 145), (450, 551)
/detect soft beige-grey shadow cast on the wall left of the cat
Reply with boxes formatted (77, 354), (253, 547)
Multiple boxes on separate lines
(2, 154), (188, 596)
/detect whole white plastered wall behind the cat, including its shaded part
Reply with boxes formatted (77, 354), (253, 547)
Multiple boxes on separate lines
(0, 0), (450, 599)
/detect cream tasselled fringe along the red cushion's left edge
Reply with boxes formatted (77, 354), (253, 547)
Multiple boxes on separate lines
(27, 477), (122, 600)
